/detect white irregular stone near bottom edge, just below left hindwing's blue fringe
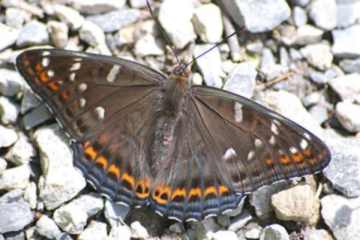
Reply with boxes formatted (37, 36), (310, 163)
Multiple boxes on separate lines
(54, 195), (104, 234)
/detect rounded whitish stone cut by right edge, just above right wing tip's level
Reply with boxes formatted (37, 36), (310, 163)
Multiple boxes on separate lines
(335, 101), (360, 133)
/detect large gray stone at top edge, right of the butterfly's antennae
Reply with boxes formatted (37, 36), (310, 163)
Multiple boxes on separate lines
(228, 0), (291, 33)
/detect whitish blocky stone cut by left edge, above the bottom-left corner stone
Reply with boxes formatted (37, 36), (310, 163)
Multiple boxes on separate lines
(0, 165), (30, 190)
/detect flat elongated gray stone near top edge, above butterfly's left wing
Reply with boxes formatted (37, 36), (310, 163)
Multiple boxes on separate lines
(86, 9), (140, 33)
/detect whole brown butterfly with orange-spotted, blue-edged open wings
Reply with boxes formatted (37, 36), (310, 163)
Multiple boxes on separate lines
(16, 49), (330, 221)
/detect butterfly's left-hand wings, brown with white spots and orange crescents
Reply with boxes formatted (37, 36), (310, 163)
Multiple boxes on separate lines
(17, 49), (166, 205)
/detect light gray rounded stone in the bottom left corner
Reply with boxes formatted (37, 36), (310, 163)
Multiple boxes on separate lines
(0, 200), (34, 233)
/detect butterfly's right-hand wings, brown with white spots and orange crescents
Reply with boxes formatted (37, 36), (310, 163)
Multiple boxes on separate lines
(152, 87), (330, 220)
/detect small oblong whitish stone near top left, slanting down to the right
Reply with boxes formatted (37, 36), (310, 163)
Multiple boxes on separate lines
(53, 4), (85, 30)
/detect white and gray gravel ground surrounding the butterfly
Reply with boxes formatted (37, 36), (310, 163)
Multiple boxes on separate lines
(0, 0), (360, 240)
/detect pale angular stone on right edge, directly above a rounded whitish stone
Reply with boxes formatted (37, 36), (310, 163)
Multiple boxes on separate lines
(329, 73), (360, 100)
